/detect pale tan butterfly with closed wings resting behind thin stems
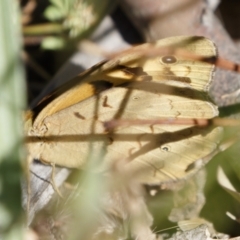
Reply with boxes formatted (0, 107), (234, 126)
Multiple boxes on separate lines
(25, 36), (222, 185)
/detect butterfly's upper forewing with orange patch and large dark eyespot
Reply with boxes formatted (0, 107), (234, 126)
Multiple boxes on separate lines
(30, 36), (217, 128)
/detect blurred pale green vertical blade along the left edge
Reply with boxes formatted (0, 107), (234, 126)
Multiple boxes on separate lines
(0, 0), (26, 239)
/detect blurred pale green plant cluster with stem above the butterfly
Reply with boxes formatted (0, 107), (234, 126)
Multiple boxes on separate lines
(23, 0), (117, 50)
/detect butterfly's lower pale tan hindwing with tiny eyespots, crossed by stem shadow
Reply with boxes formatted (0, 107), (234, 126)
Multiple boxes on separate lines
(27, 83), (221, 184)
